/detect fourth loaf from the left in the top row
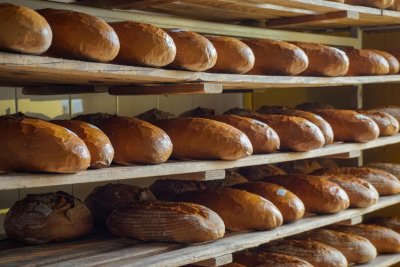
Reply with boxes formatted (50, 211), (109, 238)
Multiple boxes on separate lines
(167, 29), (217, 71)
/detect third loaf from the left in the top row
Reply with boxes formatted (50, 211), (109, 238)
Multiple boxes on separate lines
(110, 21), (176, 67)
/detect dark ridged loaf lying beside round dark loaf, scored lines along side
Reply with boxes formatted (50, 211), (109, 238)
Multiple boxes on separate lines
(107, 201), (225, 243)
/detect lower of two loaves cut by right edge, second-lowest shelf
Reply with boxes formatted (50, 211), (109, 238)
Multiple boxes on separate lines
(315, 167), (400, 196)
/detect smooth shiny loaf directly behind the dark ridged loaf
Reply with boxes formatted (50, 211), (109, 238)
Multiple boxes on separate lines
(174, 187), (283, 231)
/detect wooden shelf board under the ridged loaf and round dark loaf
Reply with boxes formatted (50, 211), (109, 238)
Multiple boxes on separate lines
(0, 195), (400, 267)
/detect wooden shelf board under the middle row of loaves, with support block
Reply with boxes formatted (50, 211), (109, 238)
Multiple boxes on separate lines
(0, 135), (400, 190)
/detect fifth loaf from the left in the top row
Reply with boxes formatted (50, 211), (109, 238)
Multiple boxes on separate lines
(205, 35), (255, 74)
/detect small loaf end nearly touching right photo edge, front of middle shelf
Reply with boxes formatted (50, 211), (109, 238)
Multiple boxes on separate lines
(357, 110), (400, 136)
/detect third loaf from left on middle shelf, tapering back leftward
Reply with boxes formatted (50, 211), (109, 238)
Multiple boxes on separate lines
(74, 113), (172, 164)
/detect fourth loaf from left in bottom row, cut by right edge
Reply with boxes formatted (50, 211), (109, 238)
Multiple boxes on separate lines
(329, 224), (400, 254)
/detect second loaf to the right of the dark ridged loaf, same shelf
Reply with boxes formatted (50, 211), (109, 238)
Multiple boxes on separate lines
(233, 182), (305, 222)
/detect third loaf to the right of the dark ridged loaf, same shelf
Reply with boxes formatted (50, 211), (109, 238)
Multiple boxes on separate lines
(262, 175), (350, 213)
